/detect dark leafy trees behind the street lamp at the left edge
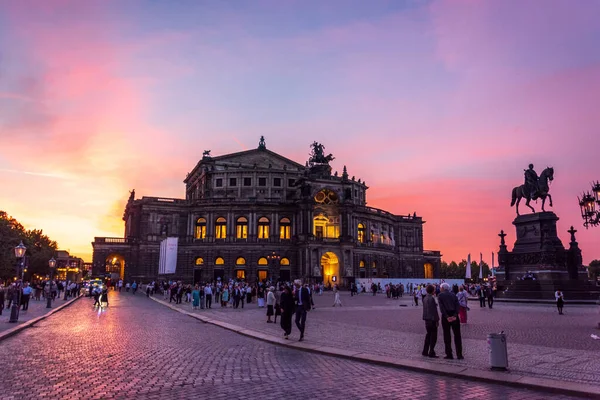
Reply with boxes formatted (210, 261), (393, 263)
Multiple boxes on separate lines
(0, 211), (57, 279)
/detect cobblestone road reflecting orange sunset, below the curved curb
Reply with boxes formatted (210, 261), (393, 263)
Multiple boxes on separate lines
(0, 294), (580, 400)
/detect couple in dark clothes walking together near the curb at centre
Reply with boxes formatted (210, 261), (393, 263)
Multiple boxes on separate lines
(280, 279), (312, 342)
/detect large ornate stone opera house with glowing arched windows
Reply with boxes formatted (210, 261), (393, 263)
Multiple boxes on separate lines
(92, 137), (441, 285)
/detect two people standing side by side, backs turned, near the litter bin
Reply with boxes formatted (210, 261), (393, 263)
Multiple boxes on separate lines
(423, 283), (464, 360)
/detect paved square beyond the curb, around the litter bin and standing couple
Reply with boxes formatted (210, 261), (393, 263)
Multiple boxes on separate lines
(159, 293), (600, 385)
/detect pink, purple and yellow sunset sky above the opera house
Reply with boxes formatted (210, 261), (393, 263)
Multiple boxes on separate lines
(0, 0), (600, 263)
